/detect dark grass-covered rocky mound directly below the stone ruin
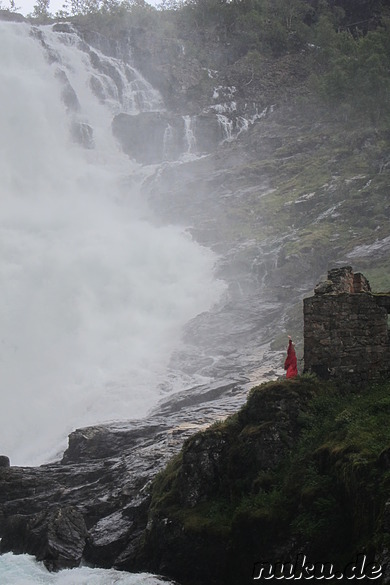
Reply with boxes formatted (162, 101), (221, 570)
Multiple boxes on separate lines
(148, 376), (390, 583)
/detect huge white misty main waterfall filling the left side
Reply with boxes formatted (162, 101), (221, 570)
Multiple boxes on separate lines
(0, 23), (223, 465)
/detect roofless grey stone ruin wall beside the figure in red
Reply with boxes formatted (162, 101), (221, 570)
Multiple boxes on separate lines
(303, 266), (390, 384)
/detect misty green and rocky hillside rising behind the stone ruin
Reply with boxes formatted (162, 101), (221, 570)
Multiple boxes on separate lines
(67, 0), (390, 352)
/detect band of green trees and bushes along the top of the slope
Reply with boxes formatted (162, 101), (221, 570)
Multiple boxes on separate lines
(24, 0), (390, 127)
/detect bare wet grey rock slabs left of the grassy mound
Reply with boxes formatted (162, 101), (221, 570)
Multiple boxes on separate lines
(0, 382), (262, 570)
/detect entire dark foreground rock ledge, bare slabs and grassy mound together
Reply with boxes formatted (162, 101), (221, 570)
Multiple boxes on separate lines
(0, 376), (390, 585)
